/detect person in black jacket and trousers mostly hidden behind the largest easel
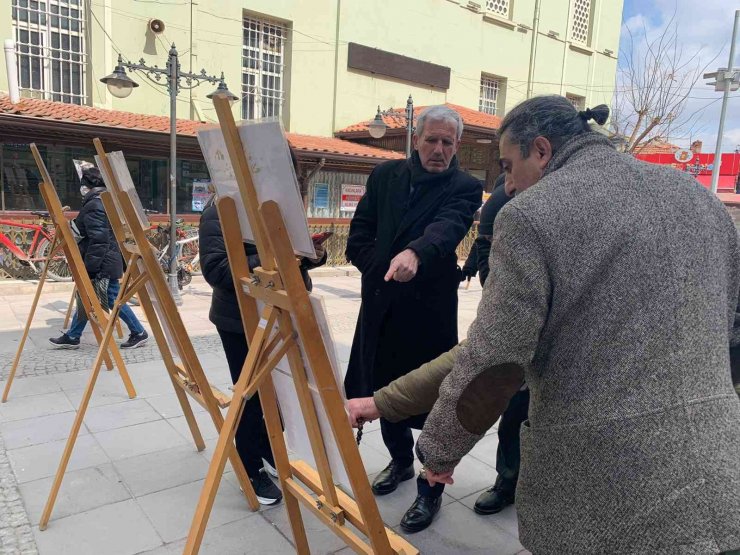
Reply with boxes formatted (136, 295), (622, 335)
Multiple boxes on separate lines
(199, 204), (326, 505)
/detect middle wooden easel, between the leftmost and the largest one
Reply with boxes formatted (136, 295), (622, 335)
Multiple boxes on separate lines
(39, 139), (259, 530)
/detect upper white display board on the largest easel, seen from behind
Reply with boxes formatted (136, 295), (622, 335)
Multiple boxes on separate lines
(198, 119), (316, 258)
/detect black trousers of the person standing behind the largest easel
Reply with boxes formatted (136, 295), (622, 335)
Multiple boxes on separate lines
(217, 330), (275, 478)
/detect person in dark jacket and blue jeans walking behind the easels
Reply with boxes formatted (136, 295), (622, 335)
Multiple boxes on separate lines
(49, 167), (149, 349)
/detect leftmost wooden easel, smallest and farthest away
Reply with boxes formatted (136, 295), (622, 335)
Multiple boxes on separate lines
(2, 144), (136, 403)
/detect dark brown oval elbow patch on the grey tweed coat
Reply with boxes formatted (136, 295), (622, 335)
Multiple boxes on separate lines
(456, 362), (524, 435)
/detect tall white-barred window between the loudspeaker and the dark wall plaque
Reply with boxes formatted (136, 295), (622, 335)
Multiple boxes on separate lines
(242, 16), (289, 119)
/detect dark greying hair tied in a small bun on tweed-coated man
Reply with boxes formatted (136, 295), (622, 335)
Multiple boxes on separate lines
(498, 94), (609, 158)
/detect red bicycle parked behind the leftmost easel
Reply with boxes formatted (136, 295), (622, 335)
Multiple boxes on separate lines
(0, 212), (72, 281)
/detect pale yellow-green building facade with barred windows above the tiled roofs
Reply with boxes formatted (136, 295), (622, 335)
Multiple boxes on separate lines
(0, 0), (623, 136)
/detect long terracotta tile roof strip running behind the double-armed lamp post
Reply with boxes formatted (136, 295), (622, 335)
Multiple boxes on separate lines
(0, 94), (403, 160)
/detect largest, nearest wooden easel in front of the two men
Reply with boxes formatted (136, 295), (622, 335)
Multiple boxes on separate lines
(184, 97), (418, 555)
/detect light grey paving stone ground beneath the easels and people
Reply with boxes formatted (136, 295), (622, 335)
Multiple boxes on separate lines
(0, 275), (526, 555)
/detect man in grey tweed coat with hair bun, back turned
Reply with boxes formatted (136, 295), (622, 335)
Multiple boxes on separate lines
(417, 96), (740, 555)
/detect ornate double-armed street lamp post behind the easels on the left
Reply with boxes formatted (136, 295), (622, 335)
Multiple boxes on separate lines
(100, 43), (238, 304)
